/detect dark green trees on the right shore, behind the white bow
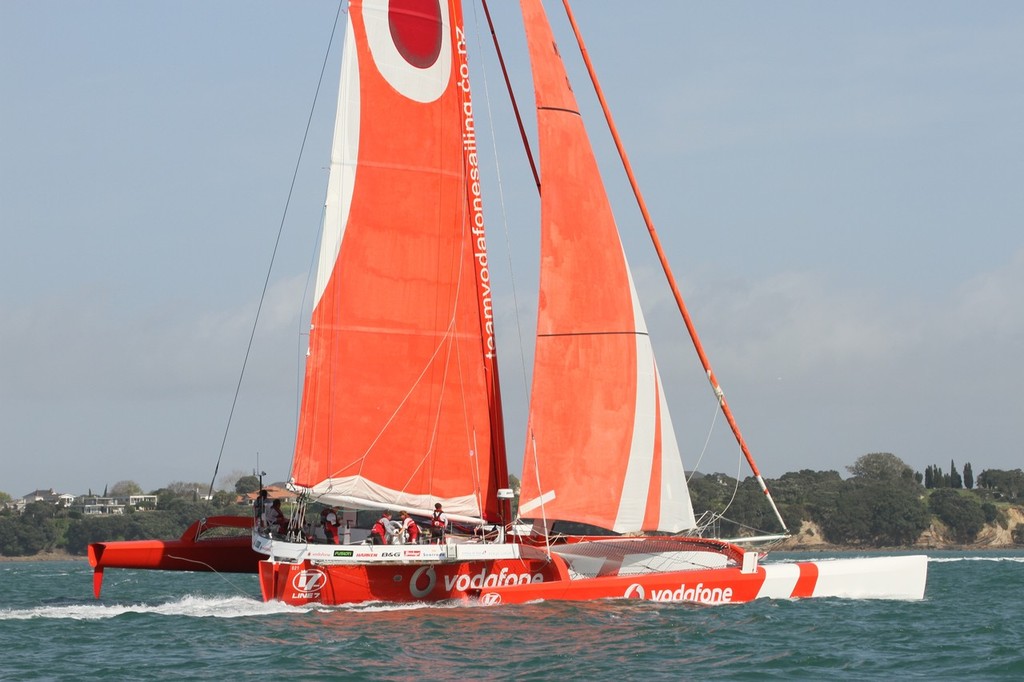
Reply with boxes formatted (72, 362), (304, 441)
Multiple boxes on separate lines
(690, 453), (1024, 548)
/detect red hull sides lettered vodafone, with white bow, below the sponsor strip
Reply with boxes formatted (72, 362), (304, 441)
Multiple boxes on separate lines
(253, 539), (928, 605)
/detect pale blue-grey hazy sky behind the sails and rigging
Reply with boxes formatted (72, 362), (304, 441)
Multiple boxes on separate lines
(0, 0), (1024, 497)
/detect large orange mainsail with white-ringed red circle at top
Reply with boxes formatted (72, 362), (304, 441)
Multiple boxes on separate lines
(292, 0), (508, 520)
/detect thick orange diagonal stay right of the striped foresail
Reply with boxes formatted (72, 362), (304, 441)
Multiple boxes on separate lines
(562, 0), (788, 532)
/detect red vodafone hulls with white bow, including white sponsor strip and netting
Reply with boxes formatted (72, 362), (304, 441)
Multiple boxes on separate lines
(259, 541), (928, 605)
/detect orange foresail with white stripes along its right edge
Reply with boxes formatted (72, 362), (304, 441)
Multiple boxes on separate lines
(519, 0), (696, 532)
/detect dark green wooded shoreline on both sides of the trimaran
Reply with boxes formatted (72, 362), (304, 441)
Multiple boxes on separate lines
(0, 453), (1024, 556)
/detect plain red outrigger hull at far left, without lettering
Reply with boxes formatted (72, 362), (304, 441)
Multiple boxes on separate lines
(89, 516), (263, 597)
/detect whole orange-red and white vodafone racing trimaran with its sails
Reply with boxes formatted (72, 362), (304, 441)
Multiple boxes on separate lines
(89, 0), (927, 604)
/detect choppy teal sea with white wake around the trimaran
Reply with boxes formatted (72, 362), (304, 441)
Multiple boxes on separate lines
(0, 550), (1024, 682)
